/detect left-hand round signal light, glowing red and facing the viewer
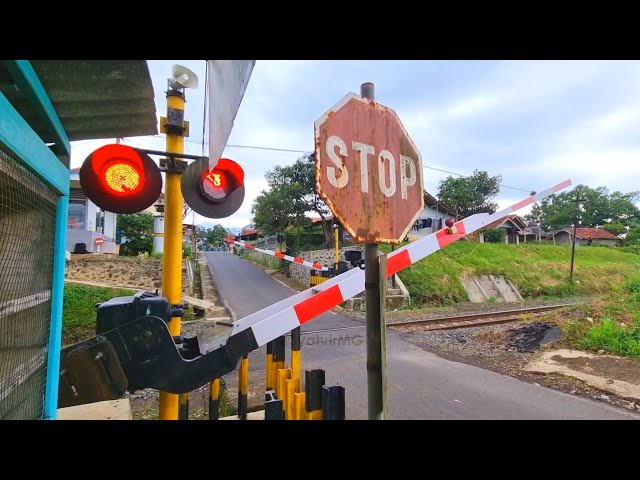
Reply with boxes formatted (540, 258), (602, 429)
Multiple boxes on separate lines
(80, 144), (162, 213)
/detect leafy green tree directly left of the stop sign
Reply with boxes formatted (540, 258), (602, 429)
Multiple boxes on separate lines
(251, 154), (333, 243)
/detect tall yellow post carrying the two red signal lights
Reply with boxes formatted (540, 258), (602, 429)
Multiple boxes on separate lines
(159, 87), (189, 420)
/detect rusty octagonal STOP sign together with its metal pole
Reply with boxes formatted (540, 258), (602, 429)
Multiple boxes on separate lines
(315, 83), (424, 420)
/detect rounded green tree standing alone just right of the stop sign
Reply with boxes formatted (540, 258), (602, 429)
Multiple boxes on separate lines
(438, 170), (502, 217)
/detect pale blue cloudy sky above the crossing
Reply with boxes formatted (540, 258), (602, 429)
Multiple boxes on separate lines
(71, 60), (640, 229)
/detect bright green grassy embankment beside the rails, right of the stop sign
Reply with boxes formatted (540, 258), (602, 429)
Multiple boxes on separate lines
(399, 242), (640, 357)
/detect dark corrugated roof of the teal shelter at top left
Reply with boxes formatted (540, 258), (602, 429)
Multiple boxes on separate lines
(0, 60), (158, 143)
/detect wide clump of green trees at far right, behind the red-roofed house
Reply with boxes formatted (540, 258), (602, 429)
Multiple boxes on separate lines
(528, 185), (640, 230)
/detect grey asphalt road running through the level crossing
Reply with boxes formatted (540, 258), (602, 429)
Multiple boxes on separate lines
(205, 252), (640, 420)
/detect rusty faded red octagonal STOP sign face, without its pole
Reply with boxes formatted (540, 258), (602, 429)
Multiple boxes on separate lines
(315, 93), (424, 243)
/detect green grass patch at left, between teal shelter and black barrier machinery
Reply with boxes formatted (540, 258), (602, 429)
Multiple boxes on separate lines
(62, 283), (135, 345)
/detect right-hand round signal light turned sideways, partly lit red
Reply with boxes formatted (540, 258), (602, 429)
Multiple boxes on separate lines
(181, 158), (245, 218)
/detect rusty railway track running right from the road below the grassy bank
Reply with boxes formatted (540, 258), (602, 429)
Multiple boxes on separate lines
(387, 303), (577, 331)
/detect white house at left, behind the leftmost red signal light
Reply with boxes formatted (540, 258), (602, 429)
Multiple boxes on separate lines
(67, 168), (120, 254)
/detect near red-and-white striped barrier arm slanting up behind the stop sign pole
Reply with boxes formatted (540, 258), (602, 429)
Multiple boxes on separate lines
(224, 180), (571, 350)
